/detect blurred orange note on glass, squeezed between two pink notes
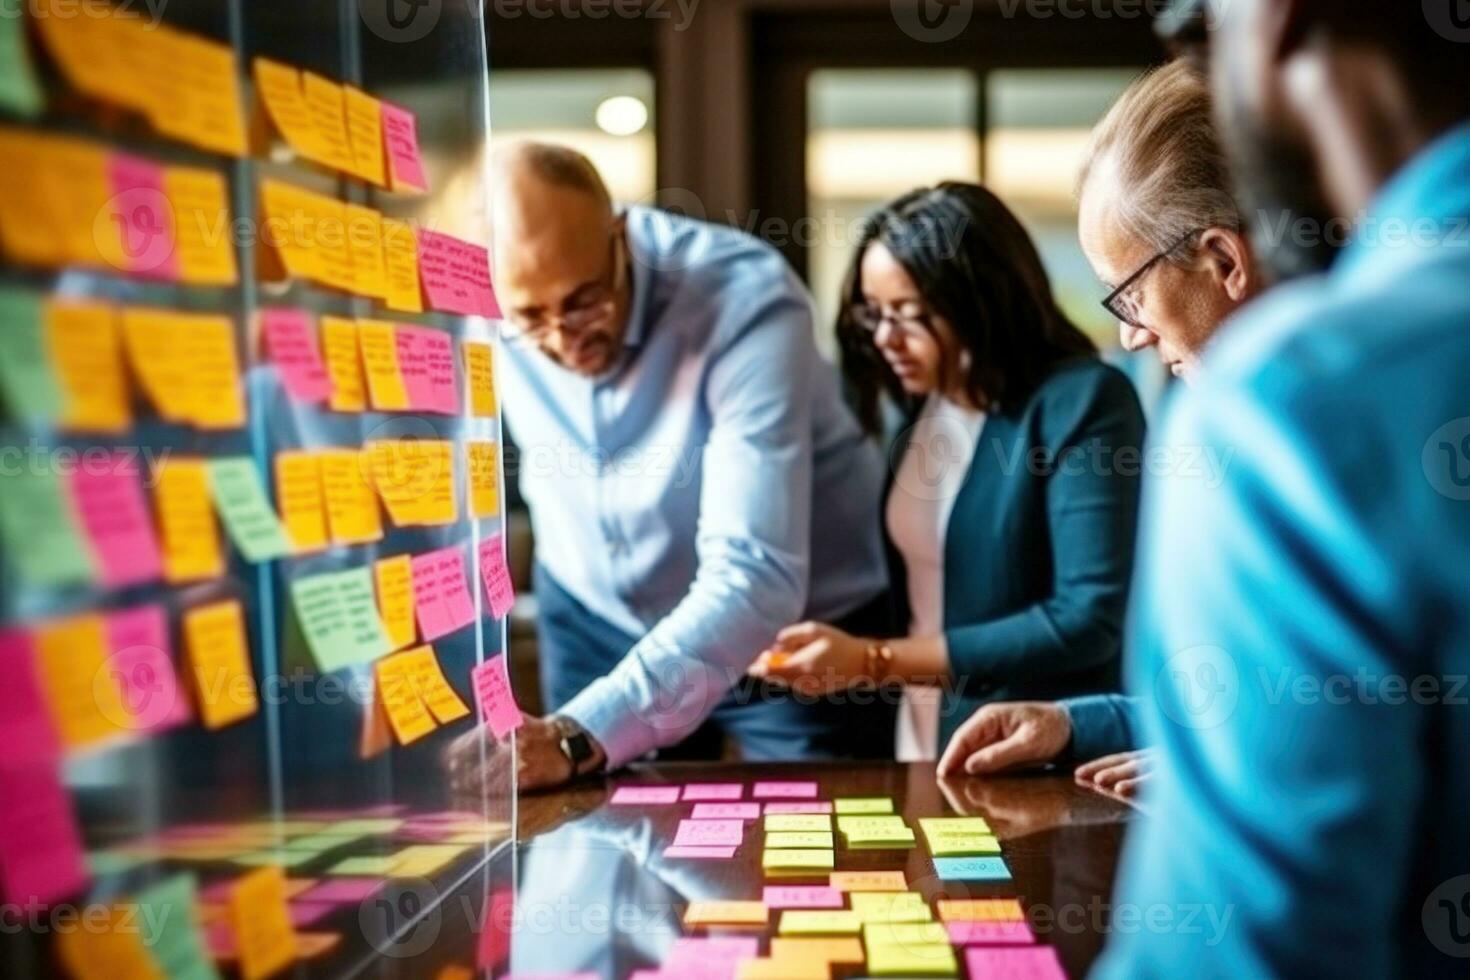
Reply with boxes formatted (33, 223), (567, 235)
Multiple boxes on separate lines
(35, 616), (132, 748)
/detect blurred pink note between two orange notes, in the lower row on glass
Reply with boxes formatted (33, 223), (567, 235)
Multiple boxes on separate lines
(107, 605), (191, 732)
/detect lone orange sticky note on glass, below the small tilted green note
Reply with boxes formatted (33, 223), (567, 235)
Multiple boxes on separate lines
(184, 599), (260, 732)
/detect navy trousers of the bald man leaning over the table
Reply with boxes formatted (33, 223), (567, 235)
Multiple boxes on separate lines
(535, 567), (900, 763)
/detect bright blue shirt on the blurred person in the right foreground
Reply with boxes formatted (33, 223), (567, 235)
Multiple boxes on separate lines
(1097, 126), (1470, 980)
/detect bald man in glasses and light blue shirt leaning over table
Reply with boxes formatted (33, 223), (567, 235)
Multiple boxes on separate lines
(465, 144), (895, 789)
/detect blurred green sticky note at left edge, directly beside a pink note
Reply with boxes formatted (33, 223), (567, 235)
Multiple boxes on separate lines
(0, 467), (93, 588)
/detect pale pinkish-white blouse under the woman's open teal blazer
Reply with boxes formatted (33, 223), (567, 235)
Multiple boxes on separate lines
(885, 395), (985, 763)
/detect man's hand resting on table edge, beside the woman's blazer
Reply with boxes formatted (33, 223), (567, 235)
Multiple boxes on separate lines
(939, 701), (1072, 776)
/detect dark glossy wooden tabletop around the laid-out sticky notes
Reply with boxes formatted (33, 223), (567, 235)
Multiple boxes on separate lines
(512, 763), (1133, 980)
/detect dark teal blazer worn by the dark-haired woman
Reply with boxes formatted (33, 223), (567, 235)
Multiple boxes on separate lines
(885, 357), (1145, 752)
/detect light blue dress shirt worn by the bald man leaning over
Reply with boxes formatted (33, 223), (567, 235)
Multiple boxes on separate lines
(501, 207), (888, 767)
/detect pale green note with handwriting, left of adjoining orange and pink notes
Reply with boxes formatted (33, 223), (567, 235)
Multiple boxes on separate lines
(291, 567), (392, 673)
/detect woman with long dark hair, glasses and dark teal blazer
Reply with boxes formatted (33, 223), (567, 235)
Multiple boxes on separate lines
(751, 184), (1144, 761)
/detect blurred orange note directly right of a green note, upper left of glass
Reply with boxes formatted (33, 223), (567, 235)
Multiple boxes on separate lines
(46, 301), (132, 433)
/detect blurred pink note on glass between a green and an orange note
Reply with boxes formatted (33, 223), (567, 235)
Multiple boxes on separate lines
(71, 453), (163, 589)
